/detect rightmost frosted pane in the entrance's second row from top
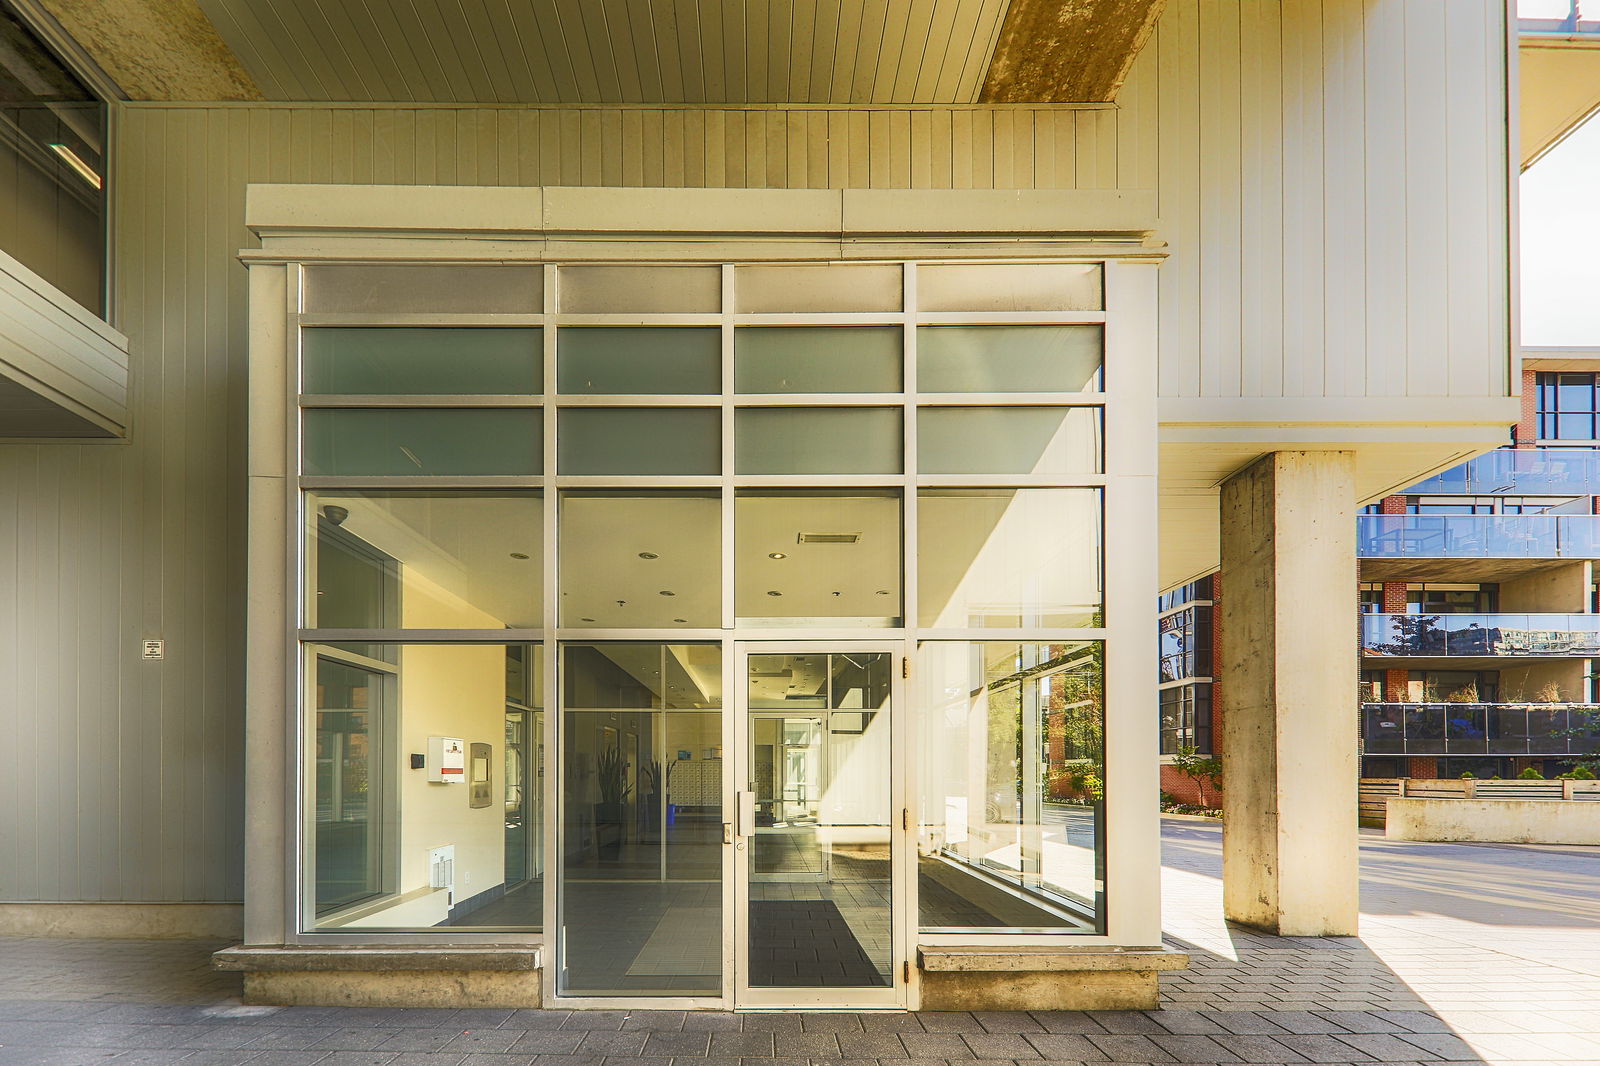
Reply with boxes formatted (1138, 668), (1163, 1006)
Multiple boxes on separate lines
(917, 325), (1106, 392)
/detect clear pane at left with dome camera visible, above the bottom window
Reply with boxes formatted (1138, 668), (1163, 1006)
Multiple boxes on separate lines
(306, 490), (544, 629)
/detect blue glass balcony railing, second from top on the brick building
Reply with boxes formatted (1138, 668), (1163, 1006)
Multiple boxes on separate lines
(1355, 514), (1600, 559)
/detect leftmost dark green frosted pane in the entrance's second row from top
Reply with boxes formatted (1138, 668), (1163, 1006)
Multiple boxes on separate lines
(301, 327), (544, 395)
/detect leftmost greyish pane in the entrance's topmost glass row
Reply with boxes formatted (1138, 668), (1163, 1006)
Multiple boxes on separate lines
(306, 264), (544, 315)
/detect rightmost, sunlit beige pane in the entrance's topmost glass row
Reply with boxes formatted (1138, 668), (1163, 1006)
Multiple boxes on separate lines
(917, 262), (1106, 311)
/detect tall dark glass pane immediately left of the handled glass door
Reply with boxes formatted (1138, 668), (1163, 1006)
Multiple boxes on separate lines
(558, 643), (723, 996)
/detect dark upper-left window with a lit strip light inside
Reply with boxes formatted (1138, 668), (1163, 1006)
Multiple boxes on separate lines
(0, 8), (106, 315)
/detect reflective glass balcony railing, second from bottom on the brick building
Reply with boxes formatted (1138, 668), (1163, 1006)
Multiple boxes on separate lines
(1362, 615), (1600, 658)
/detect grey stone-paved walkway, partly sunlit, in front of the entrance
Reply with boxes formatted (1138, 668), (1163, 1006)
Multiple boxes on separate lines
(0, 820), (1600, 1066)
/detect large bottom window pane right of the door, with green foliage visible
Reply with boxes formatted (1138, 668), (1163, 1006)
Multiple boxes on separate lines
(917, 642), (1106, 933)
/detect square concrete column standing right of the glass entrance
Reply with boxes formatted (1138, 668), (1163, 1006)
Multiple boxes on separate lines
(1221, 451), (1360, 936)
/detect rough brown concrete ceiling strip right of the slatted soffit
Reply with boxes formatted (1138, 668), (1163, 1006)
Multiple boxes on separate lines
(979, 0), (1166, 104)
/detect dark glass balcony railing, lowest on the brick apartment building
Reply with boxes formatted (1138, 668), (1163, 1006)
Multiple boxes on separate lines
(1362, 703), (1600, 755)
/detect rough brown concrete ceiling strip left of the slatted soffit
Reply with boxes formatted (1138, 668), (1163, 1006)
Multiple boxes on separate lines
(35, 0), (261, 101)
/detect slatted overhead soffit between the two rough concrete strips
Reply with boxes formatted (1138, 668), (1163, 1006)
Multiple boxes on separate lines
(198, 0), (1008, 104)
